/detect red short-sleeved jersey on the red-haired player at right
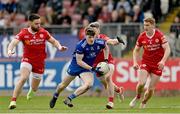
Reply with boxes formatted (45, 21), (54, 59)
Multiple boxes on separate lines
(136, 29), (167, 66)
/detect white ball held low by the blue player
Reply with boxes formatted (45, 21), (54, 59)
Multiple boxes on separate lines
(96, 62), (110, 75)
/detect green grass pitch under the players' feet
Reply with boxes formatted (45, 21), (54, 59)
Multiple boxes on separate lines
(0, 96), (180, 114)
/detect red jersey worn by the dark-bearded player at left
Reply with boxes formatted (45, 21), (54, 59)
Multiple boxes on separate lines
(16, 28), (50, 62)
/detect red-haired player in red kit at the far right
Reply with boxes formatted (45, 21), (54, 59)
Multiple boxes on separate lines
(129, 18), (170, 108)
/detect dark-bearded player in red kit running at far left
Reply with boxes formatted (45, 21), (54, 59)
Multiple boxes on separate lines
(8, 14), (67, 109)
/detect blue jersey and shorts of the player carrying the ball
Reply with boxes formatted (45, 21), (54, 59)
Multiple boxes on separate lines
(68, 38), (105, 75)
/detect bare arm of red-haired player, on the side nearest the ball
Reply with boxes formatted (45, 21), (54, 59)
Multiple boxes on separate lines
(133, 45), (140, 70)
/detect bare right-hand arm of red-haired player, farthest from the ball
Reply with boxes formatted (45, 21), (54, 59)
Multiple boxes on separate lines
(158, 42), (171, 70)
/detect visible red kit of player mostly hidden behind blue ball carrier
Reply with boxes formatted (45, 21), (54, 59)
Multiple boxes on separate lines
(94, 34), (114, 66)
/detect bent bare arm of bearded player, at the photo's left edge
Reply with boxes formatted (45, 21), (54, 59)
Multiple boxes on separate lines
(8, 39), (20, 57)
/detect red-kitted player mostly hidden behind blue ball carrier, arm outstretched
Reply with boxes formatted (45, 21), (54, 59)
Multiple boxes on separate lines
(89, 22), (124, 109)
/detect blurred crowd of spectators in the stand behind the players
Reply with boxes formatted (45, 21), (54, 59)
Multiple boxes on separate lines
(0, 0), (180, 27)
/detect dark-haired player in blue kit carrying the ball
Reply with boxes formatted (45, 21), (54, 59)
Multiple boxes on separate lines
(49, 27), (109, 108)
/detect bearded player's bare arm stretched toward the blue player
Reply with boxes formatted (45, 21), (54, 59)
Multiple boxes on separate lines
(48, 36), (68, 51)
